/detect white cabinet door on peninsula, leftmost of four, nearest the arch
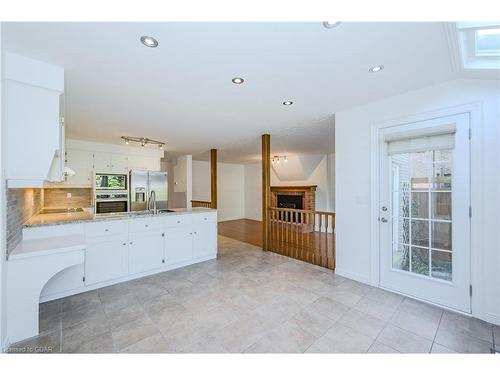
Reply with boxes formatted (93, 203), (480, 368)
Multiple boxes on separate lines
(85, 239), (128, 284)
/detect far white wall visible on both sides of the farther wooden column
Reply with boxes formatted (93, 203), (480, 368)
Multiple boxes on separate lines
(193, 160), (245, 221)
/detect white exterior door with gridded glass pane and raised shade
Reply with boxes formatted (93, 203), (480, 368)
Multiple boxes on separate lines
(379, 114), (471, 312)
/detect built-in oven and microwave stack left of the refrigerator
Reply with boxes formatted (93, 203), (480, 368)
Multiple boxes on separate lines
(94, 172), (129, 214)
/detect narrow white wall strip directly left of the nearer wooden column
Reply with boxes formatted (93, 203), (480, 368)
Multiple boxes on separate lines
(245, 162), (262, 221)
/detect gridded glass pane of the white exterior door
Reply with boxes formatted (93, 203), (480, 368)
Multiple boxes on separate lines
(391, 149), (453, 281)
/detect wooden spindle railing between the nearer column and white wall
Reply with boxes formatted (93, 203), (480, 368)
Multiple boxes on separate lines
(269, 207), (335, 269)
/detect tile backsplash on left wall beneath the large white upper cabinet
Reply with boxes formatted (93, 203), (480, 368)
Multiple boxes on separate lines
(6, 189), (43, 253)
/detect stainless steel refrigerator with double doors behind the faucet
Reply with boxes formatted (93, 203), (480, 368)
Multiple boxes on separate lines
(129, 170), (168, 211)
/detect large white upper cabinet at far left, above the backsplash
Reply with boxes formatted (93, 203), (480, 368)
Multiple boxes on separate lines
(5, 52), (64, 187)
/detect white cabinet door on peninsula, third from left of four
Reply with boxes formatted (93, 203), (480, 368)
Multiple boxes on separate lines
(165, 226), (193, 264)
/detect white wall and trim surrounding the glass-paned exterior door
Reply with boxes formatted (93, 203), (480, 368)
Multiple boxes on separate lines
(335, 80), (500, 324)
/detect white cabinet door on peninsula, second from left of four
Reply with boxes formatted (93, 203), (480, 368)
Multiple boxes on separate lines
(129, 232), (164, 274)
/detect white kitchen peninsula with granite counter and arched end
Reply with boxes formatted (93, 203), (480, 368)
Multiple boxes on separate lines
(7, 208), (217, 342)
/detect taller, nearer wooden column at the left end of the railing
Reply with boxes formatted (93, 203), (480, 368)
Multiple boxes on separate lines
(262, 134), (271, 251)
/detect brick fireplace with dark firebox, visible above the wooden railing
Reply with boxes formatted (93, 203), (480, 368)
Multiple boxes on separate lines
(271, 185), (317, 211)
